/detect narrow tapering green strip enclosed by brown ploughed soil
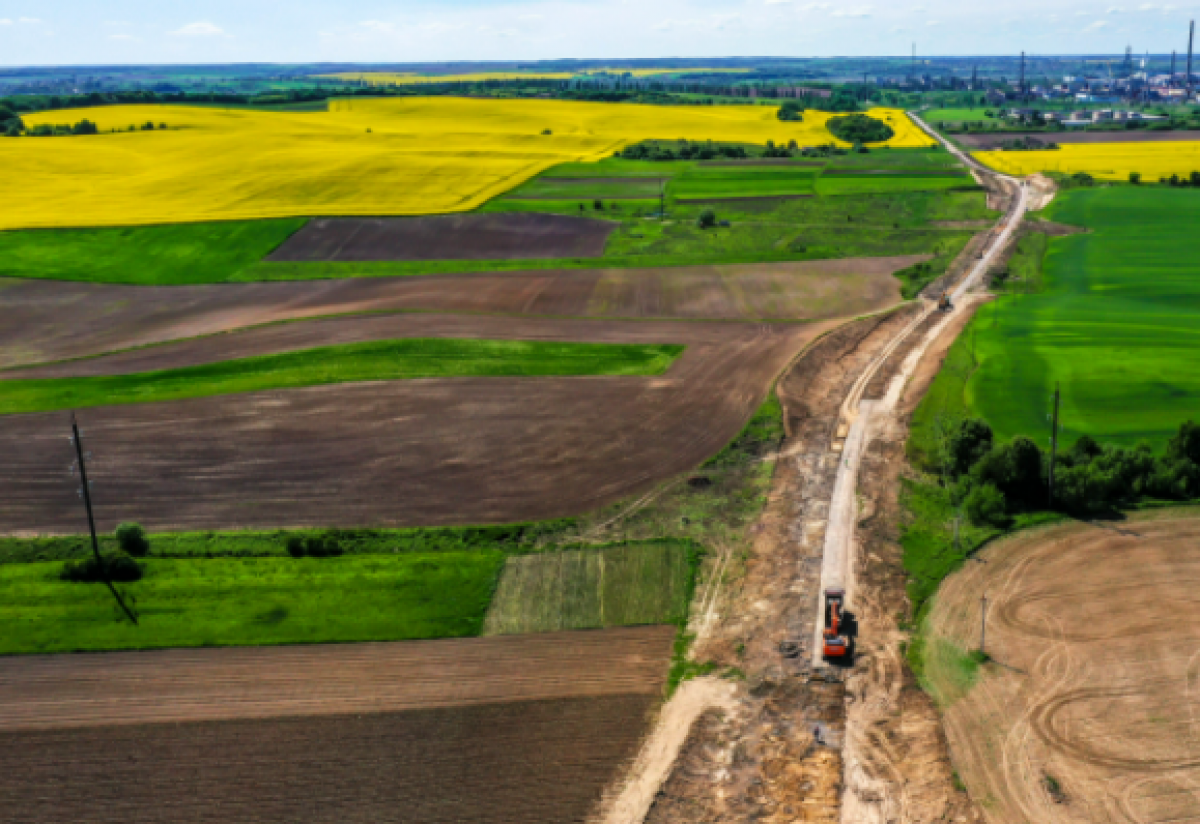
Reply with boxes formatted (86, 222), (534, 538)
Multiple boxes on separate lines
(0, 338), (683, 415)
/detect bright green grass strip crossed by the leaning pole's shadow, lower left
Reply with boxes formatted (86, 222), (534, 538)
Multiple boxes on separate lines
(0, 551), (504, 655)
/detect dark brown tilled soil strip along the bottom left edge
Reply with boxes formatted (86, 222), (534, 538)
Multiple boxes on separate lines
(0, 694), (659, 824)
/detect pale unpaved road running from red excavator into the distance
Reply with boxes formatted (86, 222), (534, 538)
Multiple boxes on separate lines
(812, 112), (1030, 667)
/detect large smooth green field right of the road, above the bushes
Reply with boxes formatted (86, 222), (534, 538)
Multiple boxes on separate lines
(914, 186), (1200, 449)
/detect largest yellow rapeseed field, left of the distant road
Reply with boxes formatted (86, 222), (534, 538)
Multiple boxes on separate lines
(0, 97), (928, 229)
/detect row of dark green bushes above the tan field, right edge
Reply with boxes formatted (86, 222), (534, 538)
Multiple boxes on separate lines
(940, 419), (1200, 527)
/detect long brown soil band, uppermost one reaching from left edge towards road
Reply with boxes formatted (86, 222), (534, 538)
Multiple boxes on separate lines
(0, 255), (928, 368)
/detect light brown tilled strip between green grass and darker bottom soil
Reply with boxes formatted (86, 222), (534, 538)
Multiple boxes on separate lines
(0, 626), (676, 735)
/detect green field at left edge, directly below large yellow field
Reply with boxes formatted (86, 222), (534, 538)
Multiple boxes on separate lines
(0, 218), (306, 284)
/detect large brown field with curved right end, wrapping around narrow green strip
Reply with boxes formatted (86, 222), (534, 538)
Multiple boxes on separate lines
(0, 314), (836, 534)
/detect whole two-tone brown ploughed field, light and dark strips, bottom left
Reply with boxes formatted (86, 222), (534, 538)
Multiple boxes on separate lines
(0, 627), (674, 824)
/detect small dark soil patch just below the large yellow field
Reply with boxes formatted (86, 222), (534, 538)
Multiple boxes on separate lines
(266, 212), (619, 261)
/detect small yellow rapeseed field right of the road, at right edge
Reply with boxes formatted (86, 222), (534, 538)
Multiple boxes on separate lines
(976, 142), (1200, 182)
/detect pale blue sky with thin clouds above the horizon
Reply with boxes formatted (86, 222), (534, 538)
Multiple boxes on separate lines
(0, 0), (1200, 66)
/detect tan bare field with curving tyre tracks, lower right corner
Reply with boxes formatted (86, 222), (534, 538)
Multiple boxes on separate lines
(926, 510), (1200, 824)
